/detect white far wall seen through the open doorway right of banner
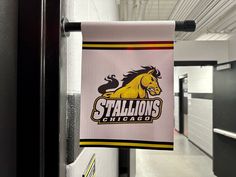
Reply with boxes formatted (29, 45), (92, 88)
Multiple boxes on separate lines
(174, 66), (213, 156)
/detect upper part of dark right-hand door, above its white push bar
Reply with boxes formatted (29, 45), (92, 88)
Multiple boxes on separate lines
(213, 61), (236, 132)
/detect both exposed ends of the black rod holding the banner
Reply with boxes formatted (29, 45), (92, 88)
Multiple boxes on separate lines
(64, 20), (196, 32)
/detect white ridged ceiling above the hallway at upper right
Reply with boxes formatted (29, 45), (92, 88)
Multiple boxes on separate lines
(117, 0), (236, 40)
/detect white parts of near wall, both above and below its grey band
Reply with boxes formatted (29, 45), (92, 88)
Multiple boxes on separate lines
(67, 0), (118, 177)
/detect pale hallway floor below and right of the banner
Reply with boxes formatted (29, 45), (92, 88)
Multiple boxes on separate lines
(136, 133), (215, 177)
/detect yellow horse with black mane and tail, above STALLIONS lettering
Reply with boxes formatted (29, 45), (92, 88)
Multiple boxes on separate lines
(98, 66), (162, 99)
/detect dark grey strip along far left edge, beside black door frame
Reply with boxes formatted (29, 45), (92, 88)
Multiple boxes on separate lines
(0, 0), (18, 177)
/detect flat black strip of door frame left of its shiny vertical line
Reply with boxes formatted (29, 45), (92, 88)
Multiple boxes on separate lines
(17, 0), (43, 177)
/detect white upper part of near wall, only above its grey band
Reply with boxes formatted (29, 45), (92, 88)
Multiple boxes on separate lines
(67, 0), (119, 93)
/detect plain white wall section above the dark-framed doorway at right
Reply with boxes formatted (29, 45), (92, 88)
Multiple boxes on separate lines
(174, 41), (228, 63)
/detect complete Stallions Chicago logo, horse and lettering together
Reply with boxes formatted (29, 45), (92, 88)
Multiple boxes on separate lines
(91, 66), (163, 124)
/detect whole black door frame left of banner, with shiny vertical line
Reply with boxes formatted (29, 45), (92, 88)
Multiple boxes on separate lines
(17, 0), (67, 177)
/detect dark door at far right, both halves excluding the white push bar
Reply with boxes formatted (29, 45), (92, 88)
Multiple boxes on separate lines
(213, 61), (236, 177)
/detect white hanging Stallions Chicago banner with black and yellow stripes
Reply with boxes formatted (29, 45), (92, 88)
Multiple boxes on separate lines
(80, 21), (175, 150)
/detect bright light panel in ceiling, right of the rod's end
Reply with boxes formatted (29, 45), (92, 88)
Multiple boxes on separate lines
(196, 33), (230, 41)
